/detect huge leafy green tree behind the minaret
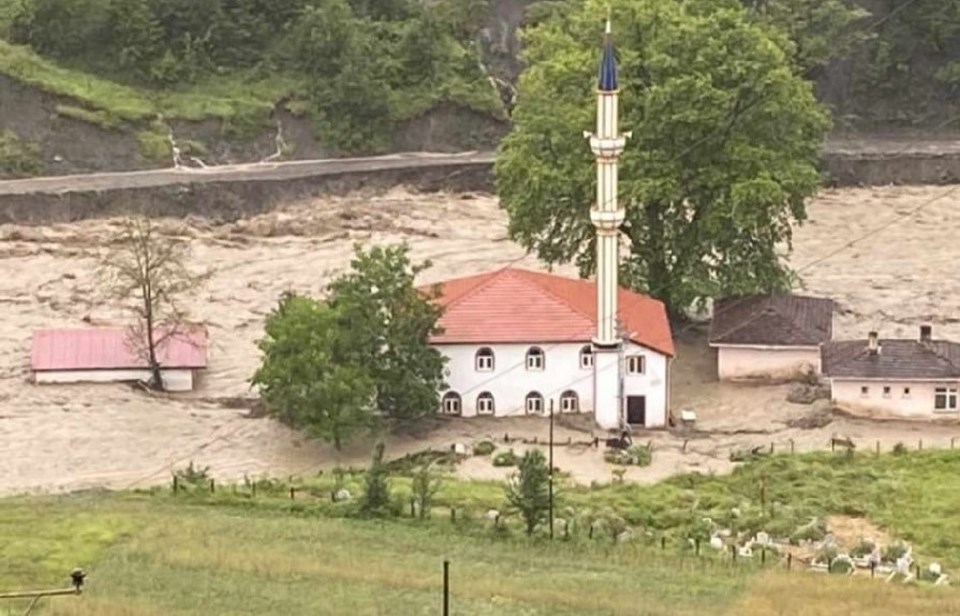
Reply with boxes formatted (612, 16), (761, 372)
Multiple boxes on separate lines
(495, 0), (829, 315)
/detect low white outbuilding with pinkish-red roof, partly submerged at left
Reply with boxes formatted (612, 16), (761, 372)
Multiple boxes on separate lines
(30, 328), (207, 391)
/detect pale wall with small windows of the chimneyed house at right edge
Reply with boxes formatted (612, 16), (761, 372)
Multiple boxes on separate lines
(830, 379), (960, 418)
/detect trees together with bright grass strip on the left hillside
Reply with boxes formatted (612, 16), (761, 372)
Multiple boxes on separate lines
(0, 0), (503, 152)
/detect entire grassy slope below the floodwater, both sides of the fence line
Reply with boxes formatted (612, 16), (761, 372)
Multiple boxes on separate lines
(0, 452), (960, 616)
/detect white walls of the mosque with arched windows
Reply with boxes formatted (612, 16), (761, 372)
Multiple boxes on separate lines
(436, 343), (668, 427)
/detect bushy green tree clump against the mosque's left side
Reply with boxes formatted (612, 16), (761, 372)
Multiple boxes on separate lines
(246, 245), (444, 449)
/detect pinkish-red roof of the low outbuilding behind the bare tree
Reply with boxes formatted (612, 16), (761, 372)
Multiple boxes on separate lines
(30, 327), (207, 371)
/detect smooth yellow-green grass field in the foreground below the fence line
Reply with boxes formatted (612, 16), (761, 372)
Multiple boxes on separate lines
(0, 495), (960, 616)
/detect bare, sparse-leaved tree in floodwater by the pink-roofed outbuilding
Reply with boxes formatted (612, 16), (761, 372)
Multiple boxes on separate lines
(98, 217), (210, 390)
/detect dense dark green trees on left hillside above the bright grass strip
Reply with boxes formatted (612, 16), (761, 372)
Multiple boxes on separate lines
(9, 0), (502, 152)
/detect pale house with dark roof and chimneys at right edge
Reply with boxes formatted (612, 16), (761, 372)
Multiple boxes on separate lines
(822, 325), (960, 417)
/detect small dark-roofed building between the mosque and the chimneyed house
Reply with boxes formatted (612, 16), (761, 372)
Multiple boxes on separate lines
(709, 295), (835, 380)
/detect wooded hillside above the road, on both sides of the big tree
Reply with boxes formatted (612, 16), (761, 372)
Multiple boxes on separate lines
(0, 0), (960, 177)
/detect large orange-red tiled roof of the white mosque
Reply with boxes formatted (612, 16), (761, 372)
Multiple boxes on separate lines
(422, 268), (674, 356)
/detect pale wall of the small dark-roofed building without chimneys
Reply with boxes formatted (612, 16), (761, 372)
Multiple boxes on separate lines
(716, 345), (820, 380)
